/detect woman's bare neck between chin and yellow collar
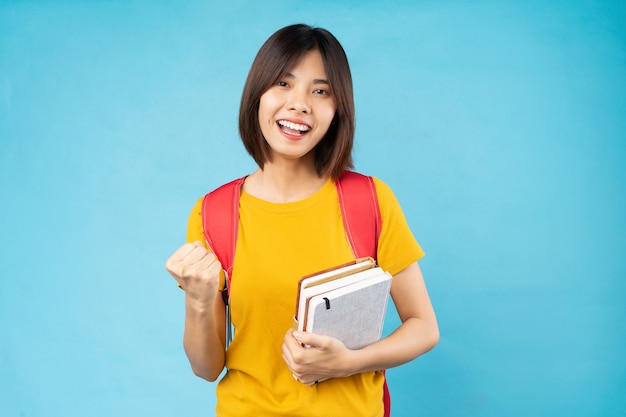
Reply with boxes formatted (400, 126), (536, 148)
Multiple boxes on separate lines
(243, 162), (328, 203)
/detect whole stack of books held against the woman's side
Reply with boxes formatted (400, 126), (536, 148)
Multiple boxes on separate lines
(295, 258), (392, 349)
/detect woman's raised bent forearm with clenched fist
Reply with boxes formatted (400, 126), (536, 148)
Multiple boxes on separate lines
(165, 242), (226, 381)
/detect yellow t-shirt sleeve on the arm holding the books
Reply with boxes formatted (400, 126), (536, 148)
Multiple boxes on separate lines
(374, 178), (424, 275)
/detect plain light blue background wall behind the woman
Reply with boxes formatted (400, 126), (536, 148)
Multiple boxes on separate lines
(0, 0), (626, 417)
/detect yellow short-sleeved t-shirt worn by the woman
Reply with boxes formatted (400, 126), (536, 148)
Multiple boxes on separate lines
(187, 179), (424, 417)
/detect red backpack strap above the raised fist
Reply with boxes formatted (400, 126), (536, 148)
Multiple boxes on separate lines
(202, 177), (245, 289)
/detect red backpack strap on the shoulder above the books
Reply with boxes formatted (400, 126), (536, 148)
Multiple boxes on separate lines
(336, 171), (382, 259)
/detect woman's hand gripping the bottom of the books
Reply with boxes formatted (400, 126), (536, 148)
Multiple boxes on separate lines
(282, 329), (353, 385)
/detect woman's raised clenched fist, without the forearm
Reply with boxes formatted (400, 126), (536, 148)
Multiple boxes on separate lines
(165, 242), (223, 305)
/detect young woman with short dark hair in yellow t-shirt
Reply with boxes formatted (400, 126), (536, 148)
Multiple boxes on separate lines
(166, 25), (439, 417)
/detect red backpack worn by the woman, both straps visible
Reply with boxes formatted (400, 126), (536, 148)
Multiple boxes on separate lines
(201, 171), (391, 417)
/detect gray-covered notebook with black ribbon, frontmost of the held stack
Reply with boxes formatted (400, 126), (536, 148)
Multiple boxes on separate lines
(306, 268), (391, 349)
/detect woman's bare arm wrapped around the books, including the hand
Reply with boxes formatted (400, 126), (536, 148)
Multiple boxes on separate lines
(283, 262), (439, 383)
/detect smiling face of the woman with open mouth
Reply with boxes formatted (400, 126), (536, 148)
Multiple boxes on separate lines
(259, 50), (336, 169)
